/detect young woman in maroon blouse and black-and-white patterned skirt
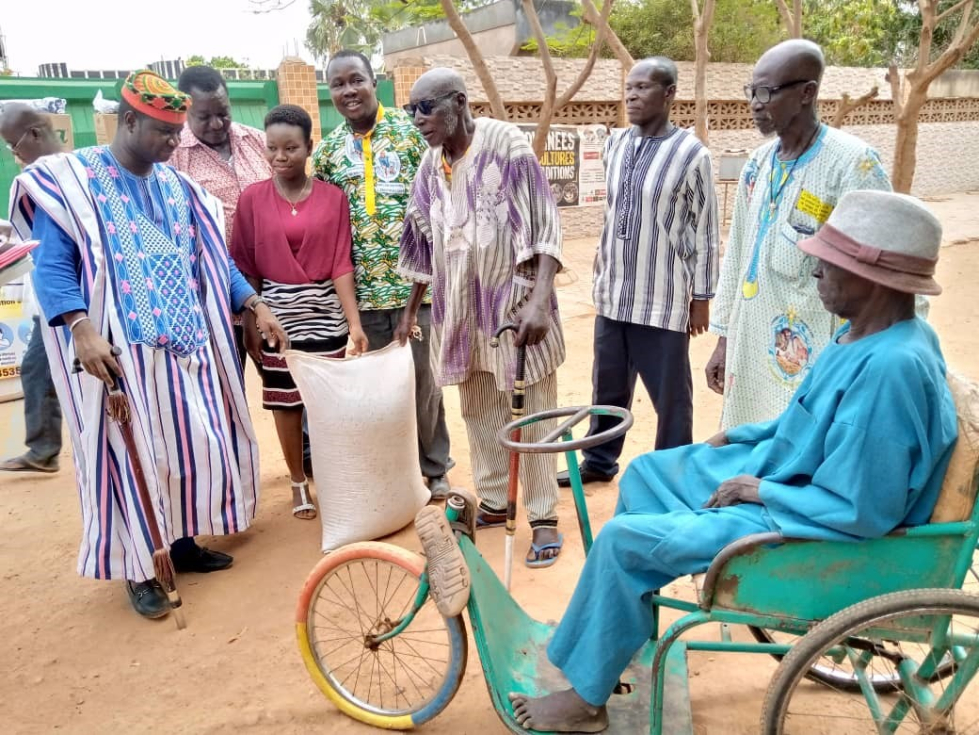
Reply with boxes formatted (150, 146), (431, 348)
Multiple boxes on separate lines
(231, 105), (367, 519)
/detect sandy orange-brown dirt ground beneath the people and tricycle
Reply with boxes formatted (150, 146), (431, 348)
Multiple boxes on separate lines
(0, 192), (979, 735)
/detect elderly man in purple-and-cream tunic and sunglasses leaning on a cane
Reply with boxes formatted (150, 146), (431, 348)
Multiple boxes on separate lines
(397, 69), (564, 567)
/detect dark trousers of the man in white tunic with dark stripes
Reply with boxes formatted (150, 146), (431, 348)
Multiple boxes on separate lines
(583, 316), (693, 475)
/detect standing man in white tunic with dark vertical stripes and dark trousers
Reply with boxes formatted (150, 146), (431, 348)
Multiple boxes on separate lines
(558, 57), (720, 486)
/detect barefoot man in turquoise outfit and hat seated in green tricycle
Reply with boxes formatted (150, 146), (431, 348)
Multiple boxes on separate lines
(510, 191), (957, 732)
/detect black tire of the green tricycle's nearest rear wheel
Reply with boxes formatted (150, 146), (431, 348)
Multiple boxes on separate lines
(761, 589), (979, 735)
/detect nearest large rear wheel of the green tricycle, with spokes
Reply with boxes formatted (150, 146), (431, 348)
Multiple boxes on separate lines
(761, 589), (979, 735)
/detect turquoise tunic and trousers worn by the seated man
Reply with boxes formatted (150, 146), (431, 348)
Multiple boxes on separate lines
(548, 318), (957, 706)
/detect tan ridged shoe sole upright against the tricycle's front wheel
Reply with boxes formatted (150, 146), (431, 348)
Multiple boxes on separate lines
(415, 505), (471, 618)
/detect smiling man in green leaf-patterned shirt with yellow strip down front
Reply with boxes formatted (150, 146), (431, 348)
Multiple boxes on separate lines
(313, 51), (449, 498)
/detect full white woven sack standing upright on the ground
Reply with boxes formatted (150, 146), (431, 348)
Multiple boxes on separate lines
(285, 343), (429, 552)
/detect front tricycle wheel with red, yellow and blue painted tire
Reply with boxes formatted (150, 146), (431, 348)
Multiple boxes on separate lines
(296, 543), (468, 730)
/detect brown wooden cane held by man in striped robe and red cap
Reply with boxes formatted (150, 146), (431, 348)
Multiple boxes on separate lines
(72, 345), (187, 630)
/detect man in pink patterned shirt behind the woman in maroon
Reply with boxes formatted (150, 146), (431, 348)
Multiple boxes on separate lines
(170, 66), (272, 367)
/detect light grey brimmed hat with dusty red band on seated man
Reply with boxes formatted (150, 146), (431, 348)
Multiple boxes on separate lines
(799, 191), (942, 296)
